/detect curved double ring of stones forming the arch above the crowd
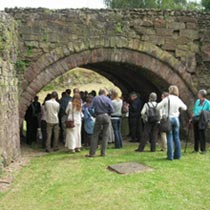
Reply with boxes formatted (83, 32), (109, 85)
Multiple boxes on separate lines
(19, 37), (195, 122)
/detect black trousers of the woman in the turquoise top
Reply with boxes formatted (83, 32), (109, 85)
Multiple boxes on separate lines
(193, 120), (206, 152)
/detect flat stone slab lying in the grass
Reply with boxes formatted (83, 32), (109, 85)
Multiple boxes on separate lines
(108, 162), (153, 174)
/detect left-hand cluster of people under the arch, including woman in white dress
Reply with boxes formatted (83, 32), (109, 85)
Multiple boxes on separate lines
(25, 88), (123, 156)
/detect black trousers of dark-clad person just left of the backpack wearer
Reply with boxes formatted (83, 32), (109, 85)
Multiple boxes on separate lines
(129, 117), (142, 141)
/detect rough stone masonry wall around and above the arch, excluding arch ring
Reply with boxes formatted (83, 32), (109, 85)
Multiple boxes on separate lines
(0, 9), (210, 171)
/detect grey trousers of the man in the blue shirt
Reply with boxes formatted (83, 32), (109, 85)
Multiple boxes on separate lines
(90, 114), (111, 156)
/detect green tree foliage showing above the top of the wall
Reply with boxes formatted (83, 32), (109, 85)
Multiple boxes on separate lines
(104, 0), (202, 10)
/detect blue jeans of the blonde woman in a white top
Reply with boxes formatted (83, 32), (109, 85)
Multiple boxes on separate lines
(167, 117), (181, 160)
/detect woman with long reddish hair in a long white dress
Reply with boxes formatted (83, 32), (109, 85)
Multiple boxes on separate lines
(65, 94), (82, 153)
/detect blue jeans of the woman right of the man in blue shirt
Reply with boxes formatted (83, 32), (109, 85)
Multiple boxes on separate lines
(112, 118), (122, 149)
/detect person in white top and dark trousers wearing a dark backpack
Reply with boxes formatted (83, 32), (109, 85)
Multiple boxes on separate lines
(136, 93), (160, 152)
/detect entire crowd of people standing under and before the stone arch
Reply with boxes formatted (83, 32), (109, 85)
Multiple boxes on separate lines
(25, 85), (210, 160)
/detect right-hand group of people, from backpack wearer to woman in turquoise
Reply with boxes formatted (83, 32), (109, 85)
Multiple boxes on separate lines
(136, 85), (210, 160)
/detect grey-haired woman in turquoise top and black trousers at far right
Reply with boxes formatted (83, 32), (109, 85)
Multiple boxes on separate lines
(192, 89), (210, 154)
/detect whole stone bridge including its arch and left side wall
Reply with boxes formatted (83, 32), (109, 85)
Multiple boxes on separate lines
(0, 9), (210, 169)
